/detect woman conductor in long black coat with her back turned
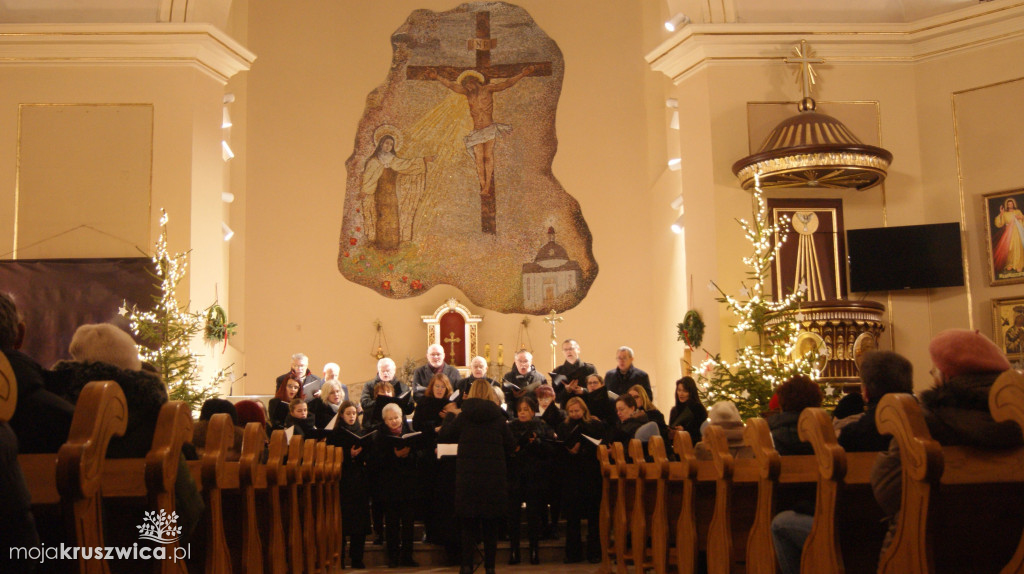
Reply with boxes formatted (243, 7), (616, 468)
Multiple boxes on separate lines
(438, 381), (515, 574)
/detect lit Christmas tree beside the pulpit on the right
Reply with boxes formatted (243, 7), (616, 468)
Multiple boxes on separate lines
(694, 178), (818, 418)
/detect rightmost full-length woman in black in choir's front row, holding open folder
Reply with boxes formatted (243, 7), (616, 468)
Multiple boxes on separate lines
(557, 397), (604, 564)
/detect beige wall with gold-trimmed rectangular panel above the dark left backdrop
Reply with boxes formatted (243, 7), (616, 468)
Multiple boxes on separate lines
(0, 64), (235, 376)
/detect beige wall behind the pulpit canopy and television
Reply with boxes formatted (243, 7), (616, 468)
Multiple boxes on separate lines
(673, 31), (1024, 387)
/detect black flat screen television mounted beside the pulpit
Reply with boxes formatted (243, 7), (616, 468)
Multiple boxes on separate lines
(846, 218), (964, 293)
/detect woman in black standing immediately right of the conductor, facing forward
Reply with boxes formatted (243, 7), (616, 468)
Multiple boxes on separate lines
(509, 395), (554, 564)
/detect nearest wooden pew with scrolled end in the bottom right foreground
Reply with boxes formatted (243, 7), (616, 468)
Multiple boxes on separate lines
(877, 378), (1024, 574)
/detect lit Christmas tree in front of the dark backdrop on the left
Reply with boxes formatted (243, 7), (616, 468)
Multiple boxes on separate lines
(128, 210), (226, 411)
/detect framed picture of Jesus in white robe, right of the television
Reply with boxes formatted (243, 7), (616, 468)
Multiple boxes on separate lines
(982, 189), (1024, 285)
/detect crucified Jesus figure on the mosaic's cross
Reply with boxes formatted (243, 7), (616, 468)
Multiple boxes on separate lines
(426, 65), (537, 195)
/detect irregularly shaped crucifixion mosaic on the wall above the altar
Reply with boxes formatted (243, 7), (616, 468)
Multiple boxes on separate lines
(338, 2), (598, 314)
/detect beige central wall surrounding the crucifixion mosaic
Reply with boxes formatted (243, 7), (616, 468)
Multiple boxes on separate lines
(239, 0), (682, 406)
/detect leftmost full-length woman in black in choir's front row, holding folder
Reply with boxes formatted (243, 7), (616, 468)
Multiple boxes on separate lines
(327, 401), (371, 570)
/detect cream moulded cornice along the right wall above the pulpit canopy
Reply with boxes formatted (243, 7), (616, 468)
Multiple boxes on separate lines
(646, 0), (1024, 85)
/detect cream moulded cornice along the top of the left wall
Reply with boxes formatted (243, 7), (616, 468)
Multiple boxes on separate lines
(0, 24), (256, 83)
